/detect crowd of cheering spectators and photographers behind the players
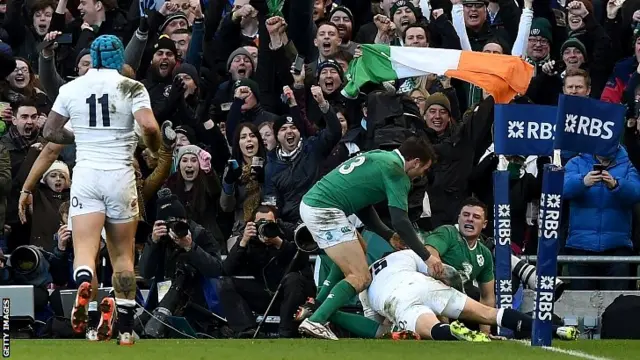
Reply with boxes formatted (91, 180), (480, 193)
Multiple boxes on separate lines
(0, 0), (640, 337)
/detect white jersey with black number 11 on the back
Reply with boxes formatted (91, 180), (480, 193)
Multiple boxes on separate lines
(52, 69), (151, 170)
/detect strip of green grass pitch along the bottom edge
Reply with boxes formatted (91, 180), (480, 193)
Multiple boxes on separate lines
(10, 339), (640, 360)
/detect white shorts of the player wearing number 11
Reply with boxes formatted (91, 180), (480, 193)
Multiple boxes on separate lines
(69, 166), (138, 224)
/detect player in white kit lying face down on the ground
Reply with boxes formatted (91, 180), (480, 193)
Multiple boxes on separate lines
(360, 250), (578, 341)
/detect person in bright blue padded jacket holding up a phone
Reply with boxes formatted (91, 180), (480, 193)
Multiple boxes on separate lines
(563, 146), (640, 290)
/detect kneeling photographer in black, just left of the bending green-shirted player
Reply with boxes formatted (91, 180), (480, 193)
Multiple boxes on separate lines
(219, 205), (316, 338)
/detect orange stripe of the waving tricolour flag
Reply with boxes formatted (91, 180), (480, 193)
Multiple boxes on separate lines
(445, 51), (533, 104)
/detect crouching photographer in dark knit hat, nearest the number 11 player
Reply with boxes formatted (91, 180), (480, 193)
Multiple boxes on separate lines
(139, 188), (222, 338)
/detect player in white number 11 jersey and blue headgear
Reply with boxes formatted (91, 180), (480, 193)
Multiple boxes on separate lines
(43, 35), (162, 345)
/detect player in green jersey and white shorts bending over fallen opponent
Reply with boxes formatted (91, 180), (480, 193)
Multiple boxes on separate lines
(299, 137), (442, 340)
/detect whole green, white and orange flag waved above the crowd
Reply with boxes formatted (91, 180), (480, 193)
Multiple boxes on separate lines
(342, 44), (533, 104)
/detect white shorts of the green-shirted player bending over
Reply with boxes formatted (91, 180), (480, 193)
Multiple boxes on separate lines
(300, 201), (358, 249)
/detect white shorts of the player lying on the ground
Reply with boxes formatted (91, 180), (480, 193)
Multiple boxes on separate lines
(368, 272), (467, 332)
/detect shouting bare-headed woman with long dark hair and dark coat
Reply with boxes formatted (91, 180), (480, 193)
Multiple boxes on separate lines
(220, 122), (266, 240)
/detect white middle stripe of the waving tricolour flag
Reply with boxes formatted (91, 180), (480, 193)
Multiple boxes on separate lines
(389, 46), (462, 79)
